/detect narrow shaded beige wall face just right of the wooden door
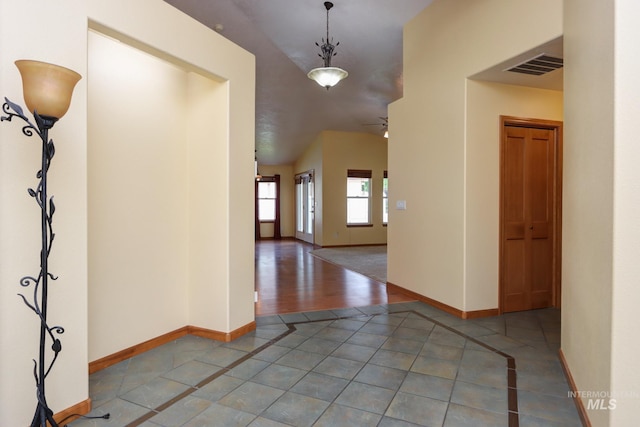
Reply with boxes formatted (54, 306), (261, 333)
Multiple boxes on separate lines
(562, 1), (614, 426)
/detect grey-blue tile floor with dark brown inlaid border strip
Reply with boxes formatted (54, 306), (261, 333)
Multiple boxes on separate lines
(69, 302), (581, 427)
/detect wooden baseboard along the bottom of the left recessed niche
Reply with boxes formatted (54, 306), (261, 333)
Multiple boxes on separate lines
(89, 320), (256, 374)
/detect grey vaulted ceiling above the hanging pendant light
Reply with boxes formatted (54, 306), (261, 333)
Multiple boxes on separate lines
(165, 0), (562, 165)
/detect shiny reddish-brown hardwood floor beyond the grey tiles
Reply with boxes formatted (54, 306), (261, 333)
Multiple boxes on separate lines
(255, 240), (414, 316)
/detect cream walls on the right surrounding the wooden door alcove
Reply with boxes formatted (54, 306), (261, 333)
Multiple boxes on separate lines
(396, 0), (640, 426)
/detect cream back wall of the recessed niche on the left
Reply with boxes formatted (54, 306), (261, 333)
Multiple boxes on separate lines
(87, 32), (189, 360)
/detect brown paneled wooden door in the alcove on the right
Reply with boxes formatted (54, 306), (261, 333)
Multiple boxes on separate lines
(500, 119), (561, 312)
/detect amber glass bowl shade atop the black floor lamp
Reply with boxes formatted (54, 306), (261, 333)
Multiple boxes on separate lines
(16, 60), (82, 119)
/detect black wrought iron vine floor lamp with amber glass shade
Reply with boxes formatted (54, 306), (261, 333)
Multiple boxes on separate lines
(0, 60), (81, 427)
